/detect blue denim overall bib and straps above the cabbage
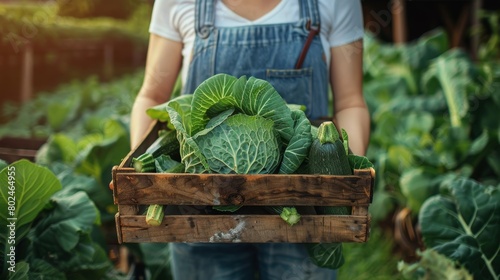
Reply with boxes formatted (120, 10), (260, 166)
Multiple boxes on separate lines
(183, 0), (329, 120)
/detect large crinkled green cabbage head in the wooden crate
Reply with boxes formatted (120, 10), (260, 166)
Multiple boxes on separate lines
(147, 74), (312, 174)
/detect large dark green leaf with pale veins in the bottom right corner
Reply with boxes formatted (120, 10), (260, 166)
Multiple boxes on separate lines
(419, 178), (500, 279)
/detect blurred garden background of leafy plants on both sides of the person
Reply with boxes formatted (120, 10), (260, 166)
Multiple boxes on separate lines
(0, 0), (500, 280)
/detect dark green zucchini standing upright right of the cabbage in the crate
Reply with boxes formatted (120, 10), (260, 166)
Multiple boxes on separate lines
(309, 121), (353, 215)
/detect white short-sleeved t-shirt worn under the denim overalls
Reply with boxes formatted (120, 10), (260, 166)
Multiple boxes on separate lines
(149, 0), (364, 83)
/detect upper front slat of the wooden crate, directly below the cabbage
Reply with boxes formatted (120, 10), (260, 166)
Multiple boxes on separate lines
(114, 171), (372, 206)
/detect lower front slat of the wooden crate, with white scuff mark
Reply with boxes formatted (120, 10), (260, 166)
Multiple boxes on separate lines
(116, 215), (370, 243)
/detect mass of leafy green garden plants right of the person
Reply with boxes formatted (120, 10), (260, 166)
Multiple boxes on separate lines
(364, 21), (500, 279)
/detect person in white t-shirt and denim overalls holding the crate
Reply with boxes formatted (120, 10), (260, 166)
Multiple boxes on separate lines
(131, 0), (370, 280)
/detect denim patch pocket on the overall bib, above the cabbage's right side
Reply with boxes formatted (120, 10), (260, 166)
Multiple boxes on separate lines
(266, 67), (314, 116)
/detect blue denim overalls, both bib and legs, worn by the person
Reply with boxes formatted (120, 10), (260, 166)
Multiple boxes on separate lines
(170, 0), (336, 280)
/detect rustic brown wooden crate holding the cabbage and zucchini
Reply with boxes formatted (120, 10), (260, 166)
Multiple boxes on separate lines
(112, 124), (375, 243)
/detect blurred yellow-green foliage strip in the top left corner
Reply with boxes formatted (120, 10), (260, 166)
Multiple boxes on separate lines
(0, 0), (151, 49)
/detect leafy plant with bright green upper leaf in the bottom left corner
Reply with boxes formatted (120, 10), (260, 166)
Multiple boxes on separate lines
(0, 160), (124, 279)
